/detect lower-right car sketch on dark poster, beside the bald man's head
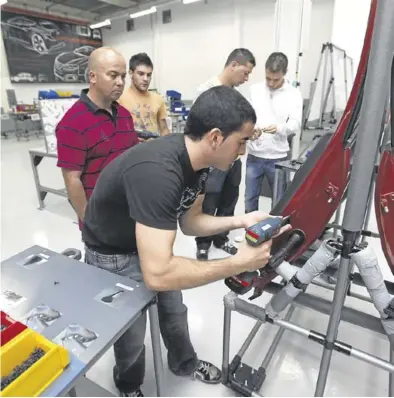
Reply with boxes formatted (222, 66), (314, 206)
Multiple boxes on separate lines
(53, 46), (94, 83)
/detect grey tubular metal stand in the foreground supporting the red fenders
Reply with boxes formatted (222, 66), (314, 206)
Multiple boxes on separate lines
(222, 1), (394, 396)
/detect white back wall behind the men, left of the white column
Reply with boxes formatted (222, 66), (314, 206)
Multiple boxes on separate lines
(103, 0), (275, 99)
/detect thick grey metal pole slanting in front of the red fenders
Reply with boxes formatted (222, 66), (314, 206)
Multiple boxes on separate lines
(315, 1), (394, 396)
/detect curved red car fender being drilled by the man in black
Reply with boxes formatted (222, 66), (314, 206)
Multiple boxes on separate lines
(273, 0), (377, 261)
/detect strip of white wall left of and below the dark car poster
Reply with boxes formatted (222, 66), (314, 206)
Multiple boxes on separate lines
(0, 32), (87, 111)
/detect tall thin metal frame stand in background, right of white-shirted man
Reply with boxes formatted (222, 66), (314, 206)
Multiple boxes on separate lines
(303, 43), (354, 130)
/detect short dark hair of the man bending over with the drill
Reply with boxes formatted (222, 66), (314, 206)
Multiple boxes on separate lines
(185, 86), (256, 141)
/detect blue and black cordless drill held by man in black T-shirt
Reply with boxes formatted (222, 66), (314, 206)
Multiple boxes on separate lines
(225, 216), (290, 294)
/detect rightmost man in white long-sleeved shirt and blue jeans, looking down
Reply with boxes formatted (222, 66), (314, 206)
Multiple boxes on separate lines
(245, 52), (303, 213)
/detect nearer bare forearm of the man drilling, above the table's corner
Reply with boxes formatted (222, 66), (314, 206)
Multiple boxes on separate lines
(144, 256), (247, 291)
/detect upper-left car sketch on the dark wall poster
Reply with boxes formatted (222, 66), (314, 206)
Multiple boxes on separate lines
(1, 16), (65, 54)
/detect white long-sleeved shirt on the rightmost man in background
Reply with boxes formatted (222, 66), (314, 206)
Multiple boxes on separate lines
(247, 81), (303, 159)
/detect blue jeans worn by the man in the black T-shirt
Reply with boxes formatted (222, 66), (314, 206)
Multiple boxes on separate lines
(85, 246), (198, 392)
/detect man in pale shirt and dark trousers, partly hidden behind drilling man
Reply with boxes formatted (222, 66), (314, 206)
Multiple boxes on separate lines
(196, 48), (256, 260)
